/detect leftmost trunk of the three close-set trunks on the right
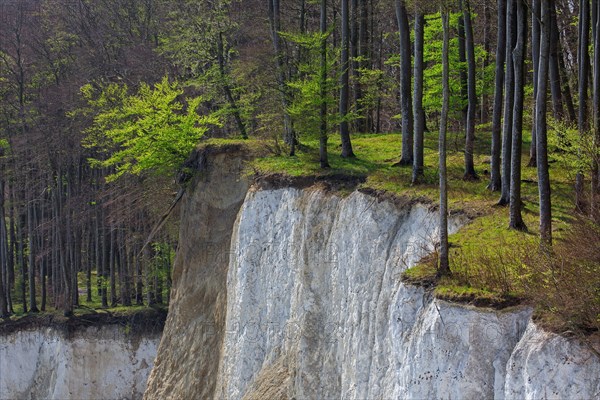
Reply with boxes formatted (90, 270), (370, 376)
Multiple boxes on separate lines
(488, 0), (506, 192)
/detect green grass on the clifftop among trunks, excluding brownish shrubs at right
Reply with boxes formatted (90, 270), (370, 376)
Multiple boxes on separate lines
(253, 127), (574, 318)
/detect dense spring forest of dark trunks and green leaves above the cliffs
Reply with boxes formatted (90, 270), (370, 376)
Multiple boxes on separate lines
(0, 0), (600, 322)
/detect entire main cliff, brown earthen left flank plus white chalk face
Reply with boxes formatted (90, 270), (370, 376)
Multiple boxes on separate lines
(145, 148), (600, 399)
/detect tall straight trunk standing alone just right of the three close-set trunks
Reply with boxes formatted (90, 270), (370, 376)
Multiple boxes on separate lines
(535, 0), (554, 246)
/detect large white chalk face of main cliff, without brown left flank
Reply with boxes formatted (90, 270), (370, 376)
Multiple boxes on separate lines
(210, 188), (600, 399)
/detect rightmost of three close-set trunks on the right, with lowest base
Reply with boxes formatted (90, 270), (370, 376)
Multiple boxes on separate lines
(509, 0), (527, 231)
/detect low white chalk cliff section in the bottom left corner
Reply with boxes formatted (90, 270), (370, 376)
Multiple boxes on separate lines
(0, 326), (160, 399)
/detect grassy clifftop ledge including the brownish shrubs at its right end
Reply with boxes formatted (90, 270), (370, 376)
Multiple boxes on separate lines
(251, 127), (600, 331)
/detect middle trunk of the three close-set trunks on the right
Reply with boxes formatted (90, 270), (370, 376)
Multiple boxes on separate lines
(498, 0), (517, 206)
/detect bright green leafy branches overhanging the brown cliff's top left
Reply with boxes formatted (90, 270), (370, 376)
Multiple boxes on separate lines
(81, 78), (219, 181)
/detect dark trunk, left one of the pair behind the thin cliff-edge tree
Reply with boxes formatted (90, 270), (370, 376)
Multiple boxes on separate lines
(396, 0), (413, 165)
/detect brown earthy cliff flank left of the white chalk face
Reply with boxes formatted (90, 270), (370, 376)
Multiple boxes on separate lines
(145, 147), (248, 400)
